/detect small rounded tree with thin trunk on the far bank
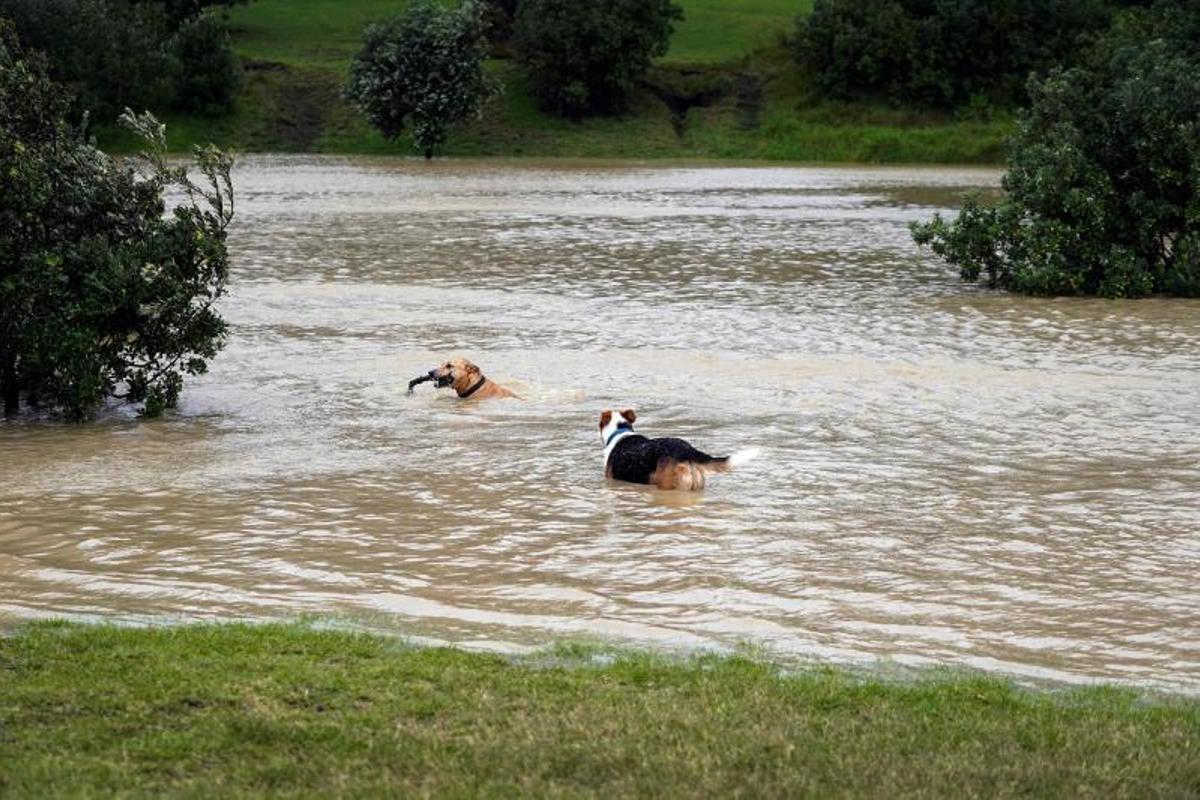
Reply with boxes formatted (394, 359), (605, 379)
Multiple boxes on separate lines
(346, 0), (498, 158)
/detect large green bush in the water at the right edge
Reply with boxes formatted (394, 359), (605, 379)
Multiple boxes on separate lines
(913, 21), (1200, 297)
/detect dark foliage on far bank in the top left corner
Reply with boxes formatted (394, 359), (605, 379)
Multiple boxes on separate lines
(0, 0), (239, 122)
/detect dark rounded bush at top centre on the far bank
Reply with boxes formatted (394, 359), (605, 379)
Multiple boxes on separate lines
(512, 0), (683, 116)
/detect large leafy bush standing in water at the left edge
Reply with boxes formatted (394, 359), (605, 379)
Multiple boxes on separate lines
(0, 22), (233, 419)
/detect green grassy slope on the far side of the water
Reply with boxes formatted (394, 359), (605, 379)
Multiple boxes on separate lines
(98, 0), (1012, 163)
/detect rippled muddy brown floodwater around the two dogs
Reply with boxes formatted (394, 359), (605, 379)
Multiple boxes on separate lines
(0, 157), (1200, 691)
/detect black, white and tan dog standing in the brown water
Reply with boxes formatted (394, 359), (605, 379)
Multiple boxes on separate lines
(600, 409), (758, 492)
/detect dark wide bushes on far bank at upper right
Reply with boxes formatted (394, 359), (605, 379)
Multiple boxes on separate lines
(796, 0), (1109, 107)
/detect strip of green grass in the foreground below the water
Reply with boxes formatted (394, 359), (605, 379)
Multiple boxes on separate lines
(0, 624), (1200, 798)
